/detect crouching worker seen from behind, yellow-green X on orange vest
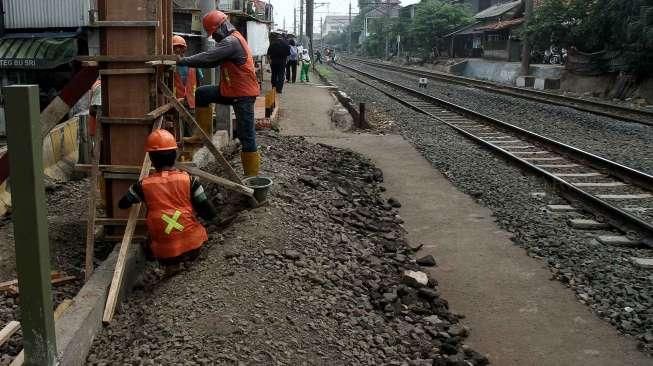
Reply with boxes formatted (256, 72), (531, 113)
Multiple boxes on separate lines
(118, 129), (216, 275)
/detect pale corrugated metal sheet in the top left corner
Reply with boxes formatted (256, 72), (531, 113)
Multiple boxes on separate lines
(3, 0), (92, 29)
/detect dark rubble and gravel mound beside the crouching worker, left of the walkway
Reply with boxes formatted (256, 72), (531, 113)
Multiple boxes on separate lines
(87, 133), (488, 366)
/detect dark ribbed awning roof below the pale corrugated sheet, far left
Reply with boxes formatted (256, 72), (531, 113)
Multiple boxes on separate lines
(0, 37), (77, 69)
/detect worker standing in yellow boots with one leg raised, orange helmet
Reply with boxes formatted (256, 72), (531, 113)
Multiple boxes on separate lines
(177, 10), (261, 177)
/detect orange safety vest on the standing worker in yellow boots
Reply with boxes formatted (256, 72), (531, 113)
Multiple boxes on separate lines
(220, 31), (261, 98)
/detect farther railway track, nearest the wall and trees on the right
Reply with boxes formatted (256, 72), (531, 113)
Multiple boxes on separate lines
(343, 57), (653, 126)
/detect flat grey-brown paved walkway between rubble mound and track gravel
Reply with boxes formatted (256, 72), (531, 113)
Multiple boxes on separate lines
(281, 81), (653, 366)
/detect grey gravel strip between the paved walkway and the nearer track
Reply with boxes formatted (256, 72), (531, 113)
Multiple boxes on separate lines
(332, 67), (653, 354)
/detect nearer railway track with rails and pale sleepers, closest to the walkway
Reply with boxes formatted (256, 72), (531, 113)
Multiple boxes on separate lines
(336, 64), (653, 247)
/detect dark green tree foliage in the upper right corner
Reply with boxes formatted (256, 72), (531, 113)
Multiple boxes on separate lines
(523, 0), (653, 74)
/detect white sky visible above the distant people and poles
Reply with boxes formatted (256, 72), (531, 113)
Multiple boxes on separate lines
(268, 0), (420, 32)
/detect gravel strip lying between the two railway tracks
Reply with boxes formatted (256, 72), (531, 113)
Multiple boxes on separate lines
(346, 64), (653, 174)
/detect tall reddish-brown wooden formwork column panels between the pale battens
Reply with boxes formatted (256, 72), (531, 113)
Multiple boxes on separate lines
(98, 0), (172, 218)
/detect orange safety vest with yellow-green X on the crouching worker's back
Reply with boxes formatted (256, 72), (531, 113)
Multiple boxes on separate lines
(142, 170), (208, 259)
